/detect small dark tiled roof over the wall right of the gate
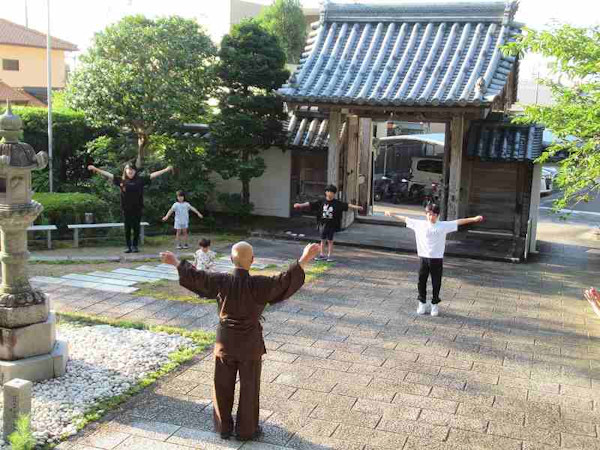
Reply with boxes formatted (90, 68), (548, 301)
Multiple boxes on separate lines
(467, 120), (544, 161)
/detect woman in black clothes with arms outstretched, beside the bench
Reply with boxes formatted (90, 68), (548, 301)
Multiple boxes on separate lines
(88, 163), (173, 253)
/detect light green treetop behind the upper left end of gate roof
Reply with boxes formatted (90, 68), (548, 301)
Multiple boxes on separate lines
(256, 0), (306, 64)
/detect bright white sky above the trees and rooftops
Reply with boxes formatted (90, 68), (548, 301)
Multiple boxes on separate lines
(0, 0), (600, 78)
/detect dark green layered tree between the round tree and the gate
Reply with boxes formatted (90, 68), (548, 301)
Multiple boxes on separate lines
(211, 21), (289, 205)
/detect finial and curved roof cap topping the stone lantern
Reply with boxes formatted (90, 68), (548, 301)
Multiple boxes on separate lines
(0, 101), (48, 169)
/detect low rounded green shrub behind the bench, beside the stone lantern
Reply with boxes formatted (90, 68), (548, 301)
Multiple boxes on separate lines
(33, 192), (113, 232)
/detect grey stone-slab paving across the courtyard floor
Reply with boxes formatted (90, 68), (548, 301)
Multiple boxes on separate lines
(44, 240), (600, 450)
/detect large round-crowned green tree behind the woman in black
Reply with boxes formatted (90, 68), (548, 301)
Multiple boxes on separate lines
(66, 15), (216, 167)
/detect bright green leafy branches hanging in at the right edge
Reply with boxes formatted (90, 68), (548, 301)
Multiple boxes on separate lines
(507, 25), (600, 210)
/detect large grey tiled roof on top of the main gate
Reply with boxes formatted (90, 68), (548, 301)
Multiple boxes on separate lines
(279, 0), (520, 106)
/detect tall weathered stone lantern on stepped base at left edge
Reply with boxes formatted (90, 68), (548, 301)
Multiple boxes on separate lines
(0, 103), (68, 384)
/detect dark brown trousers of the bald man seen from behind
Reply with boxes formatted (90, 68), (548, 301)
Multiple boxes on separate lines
(213, 357), (262, 439)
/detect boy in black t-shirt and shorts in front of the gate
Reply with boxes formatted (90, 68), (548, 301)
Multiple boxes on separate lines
(294, 184), (363, 262)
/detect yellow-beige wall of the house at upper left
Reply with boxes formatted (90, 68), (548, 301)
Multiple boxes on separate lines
(0, 45), (66, 88)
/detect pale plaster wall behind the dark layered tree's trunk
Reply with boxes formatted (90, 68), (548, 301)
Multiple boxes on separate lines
(210, 147), (292, 217)
